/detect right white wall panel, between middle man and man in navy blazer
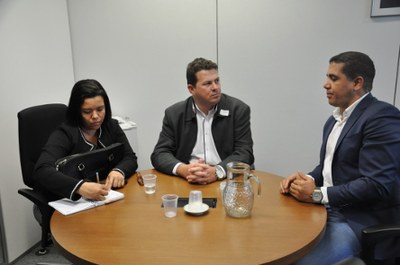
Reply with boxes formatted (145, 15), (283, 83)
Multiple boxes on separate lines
(218, 0), (400, 175)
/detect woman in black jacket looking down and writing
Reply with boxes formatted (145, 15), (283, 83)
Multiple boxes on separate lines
(34, 79), (138, 200)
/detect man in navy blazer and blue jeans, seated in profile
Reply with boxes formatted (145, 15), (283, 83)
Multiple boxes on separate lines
(281, 52), (400, 264)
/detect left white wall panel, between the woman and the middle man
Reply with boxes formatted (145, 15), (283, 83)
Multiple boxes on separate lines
(68, 0), (217, 169)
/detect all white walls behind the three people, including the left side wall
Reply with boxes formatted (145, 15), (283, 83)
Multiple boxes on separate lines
(0, 0), (400, 261)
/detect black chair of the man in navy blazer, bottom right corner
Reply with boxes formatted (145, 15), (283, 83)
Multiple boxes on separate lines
(361, 224), (400, 265)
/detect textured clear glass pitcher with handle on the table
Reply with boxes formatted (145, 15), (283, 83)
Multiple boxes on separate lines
(222, 162), (261, 218)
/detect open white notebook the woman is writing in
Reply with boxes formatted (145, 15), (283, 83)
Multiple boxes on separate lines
(49, 190), (125, 215)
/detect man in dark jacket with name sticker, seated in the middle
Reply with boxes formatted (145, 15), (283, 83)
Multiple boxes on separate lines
(151, 58), (254, 184)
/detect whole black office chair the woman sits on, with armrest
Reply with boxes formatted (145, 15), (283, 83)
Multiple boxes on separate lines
(18, 103), (67, 255)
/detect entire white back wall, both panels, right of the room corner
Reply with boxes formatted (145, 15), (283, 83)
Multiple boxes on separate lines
(69, 0), (400, 175)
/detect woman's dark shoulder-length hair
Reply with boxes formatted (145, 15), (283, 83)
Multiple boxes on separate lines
(67, 79), (111, 127)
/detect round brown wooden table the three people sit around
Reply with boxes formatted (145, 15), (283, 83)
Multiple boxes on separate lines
(51, 170), (326, 265)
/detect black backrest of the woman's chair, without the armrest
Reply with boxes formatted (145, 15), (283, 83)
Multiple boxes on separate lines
(18, 103), (67, 188)
